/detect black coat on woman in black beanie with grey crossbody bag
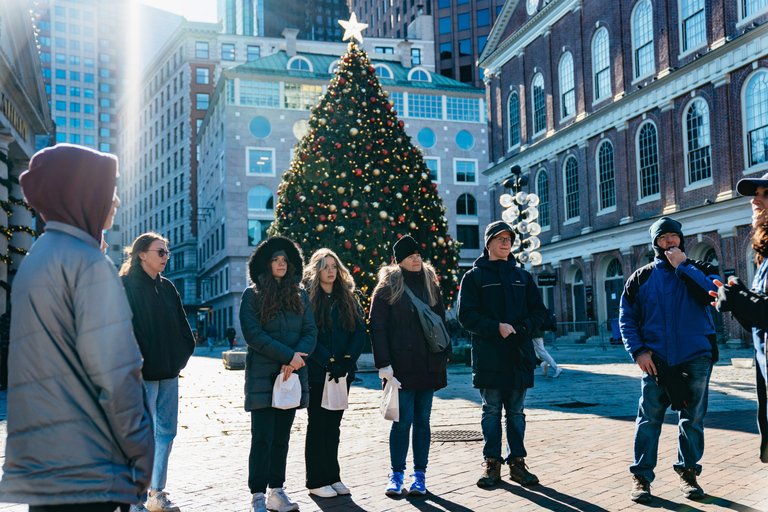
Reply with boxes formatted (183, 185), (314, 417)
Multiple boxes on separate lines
(369, 269), (451, 391)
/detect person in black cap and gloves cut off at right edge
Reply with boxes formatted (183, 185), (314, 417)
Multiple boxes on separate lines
(710, 174), (768, 462)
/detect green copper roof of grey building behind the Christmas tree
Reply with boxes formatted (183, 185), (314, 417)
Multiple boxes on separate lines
(225, 50), (485, 95)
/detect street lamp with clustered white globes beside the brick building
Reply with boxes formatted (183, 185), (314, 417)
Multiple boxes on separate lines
(499, 165), (543, 266)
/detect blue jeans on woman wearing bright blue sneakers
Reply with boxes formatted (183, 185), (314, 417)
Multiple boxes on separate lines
(389, 389), (435, 473)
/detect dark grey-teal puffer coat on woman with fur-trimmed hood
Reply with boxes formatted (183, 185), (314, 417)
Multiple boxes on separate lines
(240, 278), (317, 411)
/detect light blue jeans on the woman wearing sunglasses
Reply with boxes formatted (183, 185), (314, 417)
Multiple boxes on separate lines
(145, 377), (179, 491)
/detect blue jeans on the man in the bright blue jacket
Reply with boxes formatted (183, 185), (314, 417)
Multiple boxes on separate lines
(629, 356), (712, 482)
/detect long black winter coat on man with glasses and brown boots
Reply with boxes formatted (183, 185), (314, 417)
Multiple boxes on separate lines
(458, 255), (547, 389)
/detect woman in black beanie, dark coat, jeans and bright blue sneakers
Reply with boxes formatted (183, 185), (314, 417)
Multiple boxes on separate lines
(369, 236), (451, 496)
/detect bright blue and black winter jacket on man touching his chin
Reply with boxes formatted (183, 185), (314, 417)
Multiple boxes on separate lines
(619, 257), (720, 366)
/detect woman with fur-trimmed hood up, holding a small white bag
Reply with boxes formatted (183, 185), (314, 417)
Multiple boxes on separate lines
(240, 236), (317, 512)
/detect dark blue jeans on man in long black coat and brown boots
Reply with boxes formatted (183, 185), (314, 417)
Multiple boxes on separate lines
(480, 388), (527, 462)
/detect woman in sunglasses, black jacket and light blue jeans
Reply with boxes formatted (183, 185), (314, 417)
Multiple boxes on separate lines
(120, 232), (195, 512)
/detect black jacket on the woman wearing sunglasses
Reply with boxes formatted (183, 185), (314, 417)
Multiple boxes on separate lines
(121, 265), (195, 380)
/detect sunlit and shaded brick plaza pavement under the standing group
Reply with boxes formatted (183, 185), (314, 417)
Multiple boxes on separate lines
(0, 347), (768, 512)
